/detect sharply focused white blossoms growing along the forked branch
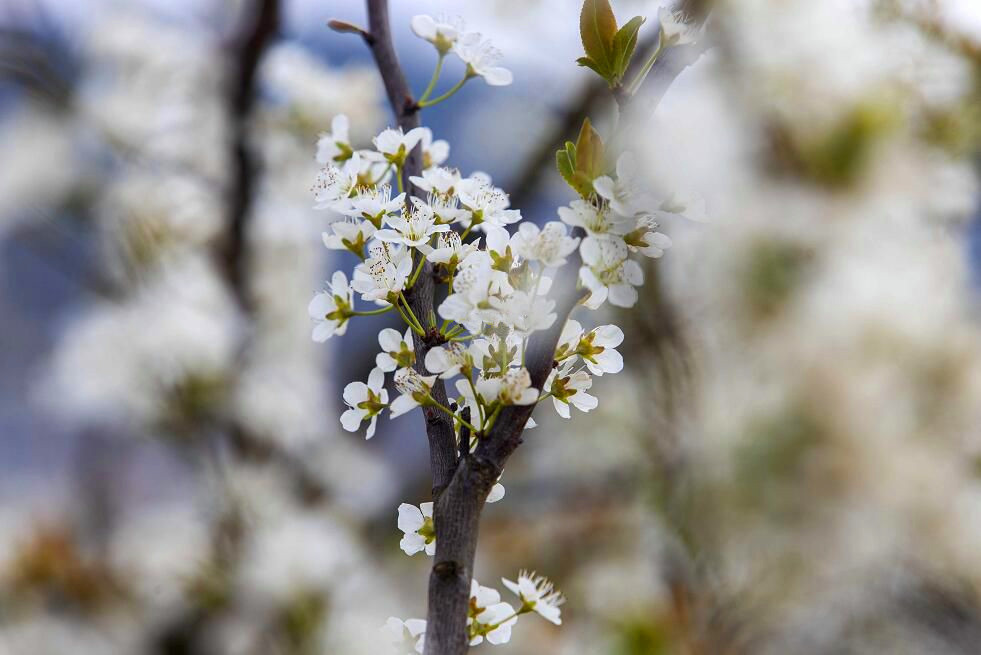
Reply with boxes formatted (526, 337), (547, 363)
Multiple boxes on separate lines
(309, 11), (688, 652)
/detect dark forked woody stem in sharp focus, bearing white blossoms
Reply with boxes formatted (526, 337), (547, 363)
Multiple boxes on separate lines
(352, 0), (704, 655)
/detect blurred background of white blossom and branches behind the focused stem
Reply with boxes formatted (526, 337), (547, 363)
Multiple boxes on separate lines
(0, 0), (981, 655)
